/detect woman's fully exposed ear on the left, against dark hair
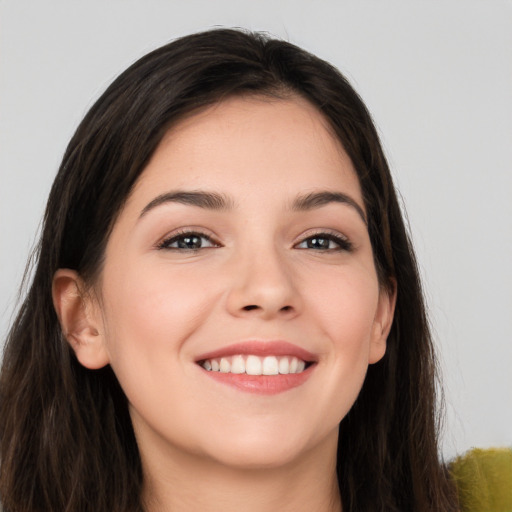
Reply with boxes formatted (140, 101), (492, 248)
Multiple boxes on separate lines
(52, 269), (109, 370)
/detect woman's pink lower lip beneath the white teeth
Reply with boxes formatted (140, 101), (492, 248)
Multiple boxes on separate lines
(201, 364), (316, 395)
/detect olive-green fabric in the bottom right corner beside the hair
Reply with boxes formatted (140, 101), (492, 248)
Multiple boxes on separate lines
(450, 448), (512, 512)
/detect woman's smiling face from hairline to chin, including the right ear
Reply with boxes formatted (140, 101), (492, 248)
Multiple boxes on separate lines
(91, 98), (393, 467)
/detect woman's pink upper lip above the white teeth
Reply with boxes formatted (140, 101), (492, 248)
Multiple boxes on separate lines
(196, 340), (317, 362)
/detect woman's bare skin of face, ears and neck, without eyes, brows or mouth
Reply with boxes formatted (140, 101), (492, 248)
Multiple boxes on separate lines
(54, 97), (394, 511)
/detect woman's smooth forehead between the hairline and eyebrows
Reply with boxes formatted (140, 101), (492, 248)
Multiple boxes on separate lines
(128, 96), (360, 208)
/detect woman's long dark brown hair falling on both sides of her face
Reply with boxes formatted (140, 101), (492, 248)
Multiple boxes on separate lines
(0, 29), (456, 512)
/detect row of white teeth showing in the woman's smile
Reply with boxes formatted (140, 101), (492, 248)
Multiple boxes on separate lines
(201, 355), (306, 375)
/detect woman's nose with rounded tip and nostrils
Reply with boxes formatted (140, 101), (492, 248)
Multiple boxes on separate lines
(227, 247), (301, 319)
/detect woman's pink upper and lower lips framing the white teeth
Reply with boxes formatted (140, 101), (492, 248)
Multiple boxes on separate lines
(196, 341), (317, 395)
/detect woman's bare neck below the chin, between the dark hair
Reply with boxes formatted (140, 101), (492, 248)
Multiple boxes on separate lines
(141, 432), (341, 512)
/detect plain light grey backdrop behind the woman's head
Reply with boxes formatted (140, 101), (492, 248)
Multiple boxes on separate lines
(0, 0), (512, 457)
